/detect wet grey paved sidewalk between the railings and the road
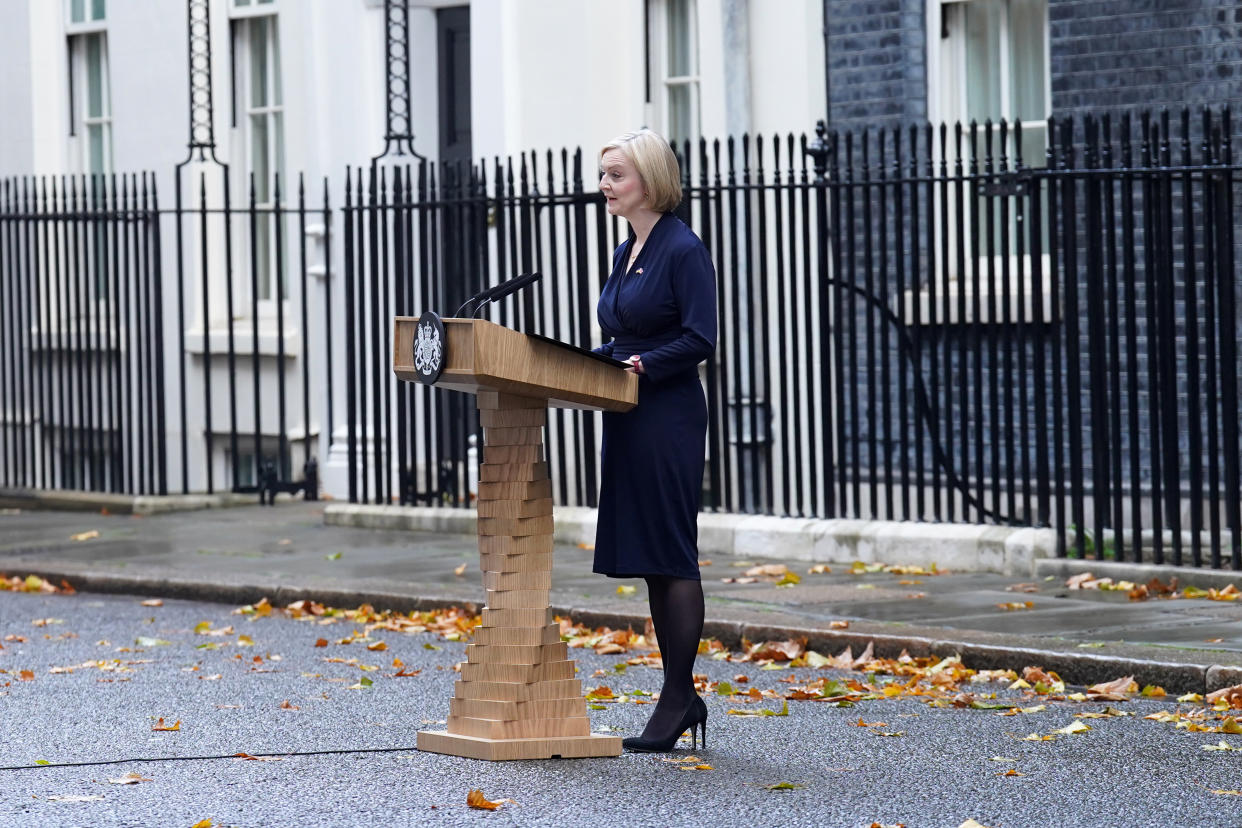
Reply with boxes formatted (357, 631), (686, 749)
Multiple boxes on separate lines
(0, 500), (1242, 693)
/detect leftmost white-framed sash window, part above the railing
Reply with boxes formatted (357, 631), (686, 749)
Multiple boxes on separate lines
(66, 0), (112, 174)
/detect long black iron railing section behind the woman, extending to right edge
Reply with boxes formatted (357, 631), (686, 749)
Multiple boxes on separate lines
(345, 106), (1242, 566)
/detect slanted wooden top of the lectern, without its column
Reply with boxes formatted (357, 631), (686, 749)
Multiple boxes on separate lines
(392, 317), (638, 411)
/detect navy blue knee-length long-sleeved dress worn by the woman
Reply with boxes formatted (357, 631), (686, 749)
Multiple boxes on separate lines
(594, 214), (717, 580)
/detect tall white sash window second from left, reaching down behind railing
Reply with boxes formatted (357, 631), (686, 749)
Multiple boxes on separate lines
(232, 0), (289, 302)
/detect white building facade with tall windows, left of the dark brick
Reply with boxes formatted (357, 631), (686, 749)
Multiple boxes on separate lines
(0, 0), (825, 498)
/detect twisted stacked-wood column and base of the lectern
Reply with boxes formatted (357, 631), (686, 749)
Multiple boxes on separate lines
(419, 391), (621, 760)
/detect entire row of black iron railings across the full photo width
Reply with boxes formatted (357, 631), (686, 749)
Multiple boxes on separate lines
(0, 110), (1242, 569)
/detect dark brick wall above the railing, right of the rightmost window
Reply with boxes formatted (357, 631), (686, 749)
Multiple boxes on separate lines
(1048, 0), (1242, 115)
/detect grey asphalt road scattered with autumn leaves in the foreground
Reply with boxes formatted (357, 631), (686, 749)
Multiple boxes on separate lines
(0, 592), (1242, 828)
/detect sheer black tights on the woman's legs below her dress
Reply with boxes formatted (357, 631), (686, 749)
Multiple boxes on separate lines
(642, 575), (703, 739)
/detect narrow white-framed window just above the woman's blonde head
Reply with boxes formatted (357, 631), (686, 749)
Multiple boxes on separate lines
(647, 0), (699, 146)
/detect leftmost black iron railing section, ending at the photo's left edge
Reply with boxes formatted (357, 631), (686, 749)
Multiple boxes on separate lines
(0, 174), (168, 494)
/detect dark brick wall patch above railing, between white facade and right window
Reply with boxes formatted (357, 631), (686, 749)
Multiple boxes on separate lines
(827, 0), (928, 130)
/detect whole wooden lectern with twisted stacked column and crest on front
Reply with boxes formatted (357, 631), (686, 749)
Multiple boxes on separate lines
(392, 314), (638, 760)
